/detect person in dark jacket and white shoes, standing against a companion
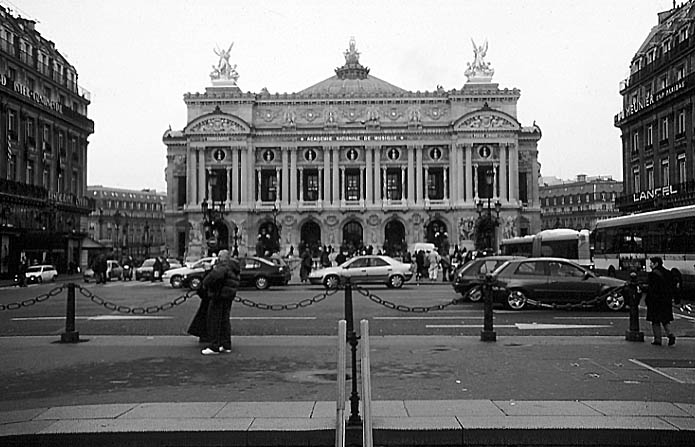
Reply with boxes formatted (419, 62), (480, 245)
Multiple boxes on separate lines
(201, 250), (241, 355)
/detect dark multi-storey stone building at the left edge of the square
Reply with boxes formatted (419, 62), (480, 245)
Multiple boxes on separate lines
(0, 6), (94, 278)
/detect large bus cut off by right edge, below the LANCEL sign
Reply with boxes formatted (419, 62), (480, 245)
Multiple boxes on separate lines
(591, 205), (695, 292)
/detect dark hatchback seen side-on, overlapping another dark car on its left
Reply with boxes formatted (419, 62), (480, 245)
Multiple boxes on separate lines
(493, 258), (625, 311)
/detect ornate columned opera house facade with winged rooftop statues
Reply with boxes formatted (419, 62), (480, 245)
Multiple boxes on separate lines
(163, 39), (541, 259)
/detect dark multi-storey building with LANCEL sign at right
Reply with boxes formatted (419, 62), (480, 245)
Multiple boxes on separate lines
(614, 1), (695, 213)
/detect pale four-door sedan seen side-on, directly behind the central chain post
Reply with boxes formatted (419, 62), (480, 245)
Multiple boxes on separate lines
(309, 255), (413, 289)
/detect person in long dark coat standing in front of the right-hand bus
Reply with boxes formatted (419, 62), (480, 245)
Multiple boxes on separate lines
(645, 256), (676, 346)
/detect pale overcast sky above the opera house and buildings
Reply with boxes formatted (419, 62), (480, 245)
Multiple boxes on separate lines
(13, 0), (681, 191)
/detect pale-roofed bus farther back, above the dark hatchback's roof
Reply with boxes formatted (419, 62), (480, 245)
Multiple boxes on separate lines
(500, 228), (594, 269)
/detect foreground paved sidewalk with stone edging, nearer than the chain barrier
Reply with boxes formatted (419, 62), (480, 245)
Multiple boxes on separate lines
(0, 334), (695, 446)
